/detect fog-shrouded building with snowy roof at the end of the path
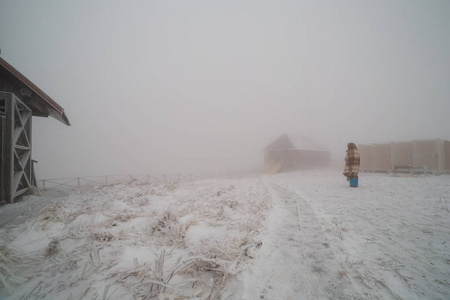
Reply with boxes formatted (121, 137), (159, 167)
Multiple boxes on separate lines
(264, 134), (331, 174)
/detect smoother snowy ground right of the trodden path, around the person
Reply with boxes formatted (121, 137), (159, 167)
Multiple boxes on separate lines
(271, 171), (450, 299)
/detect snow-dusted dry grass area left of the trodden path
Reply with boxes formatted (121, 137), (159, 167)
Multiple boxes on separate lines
(0, 177), (272, 299)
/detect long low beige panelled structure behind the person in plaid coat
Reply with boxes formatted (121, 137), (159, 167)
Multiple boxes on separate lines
(358, 139), (450, 174)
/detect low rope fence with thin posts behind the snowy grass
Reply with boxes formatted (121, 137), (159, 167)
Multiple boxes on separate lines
(36, 171), (239, 190)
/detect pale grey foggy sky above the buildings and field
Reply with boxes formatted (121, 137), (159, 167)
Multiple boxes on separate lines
(0, 0), (450, 179)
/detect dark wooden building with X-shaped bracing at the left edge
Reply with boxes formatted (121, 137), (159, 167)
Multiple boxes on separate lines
(0, 57), (70, 204)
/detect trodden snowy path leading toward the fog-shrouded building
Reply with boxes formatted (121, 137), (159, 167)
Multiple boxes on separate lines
(236, 180), (358, 299)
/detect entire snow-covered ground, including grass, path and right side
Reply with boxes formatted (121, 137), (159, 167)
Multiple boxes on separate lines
(0, 171), (450, 300)
